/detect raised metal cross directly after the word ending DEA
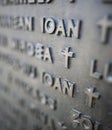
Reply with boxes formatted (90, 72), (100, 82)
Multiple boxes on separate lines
(61, 47), (75, 68)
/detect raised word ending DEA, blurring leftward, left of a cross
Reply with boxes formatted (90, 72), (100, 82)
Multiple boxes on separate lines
(12, 39), (53, 63)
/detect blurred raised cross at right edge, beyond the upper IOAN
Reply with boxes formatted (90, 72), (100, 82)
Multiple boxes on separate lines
(98, 16), (112, 43)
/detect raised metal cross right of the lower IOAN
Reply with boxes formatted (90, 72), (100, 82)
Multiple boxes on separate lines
(85, 86), (100, 107)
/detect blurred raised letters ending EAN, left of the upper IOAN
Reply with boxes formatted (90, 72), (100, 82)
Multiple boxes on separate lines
(0, 15), (34, 31)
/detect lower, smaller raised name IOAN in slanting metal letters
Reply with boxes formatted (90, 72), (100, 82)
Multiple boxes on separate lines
(42, 72), (75, 97)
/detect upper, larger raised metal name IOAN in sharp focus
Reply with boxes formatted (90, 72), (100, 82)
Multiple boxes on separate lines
(41, 17), (81, 39)
